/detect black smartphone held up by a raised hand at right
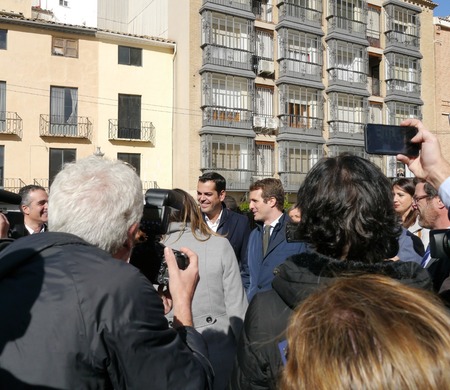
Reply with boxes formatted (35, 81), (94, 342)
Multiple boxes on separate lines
(364, 123), (420, 157)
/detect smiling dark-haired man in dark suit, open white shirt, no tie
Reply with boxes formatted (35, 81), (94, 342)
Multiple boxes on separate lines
(197, 172), (250, 264)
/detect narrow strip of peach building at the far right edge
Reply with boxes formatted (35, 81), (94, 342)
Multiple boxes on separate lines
(429, 17), (450, 154)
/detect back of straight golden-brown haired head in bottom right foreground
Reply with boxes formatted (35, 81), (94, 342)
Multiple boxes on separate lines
(281, 275), (450, 390)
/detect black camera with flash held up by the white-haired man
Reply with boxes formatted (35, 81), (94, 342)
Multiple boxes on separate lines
(130, 188), (189, 285)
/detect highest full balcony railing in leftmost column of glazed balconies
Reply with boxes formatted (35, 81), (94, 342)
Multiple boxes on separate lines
(203, 45), (252, 70)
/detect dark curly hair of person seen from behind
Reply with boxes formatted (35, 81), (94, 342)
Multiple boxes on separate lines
(297, 154), (401, 263)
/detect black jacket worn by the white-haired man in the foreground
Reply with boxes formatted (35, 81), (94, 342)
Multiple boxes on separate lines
(0, 232), (214, 389)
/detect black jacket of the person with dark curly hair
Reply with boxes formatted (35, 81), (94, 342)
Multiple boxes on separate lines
(229, 253), (431, 390)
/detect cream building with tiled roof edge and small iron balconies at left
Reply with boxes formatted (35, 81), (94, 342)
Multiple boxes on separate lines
(0, 1), (175, 191)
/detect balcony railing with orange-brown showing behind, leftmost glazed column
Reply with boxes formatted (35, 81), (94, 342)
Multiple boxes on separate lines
(203, 106), (252, 129)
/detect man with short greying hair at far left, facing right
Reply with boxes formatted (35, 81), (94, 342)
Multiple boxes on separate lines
(11, 184), (48, 238)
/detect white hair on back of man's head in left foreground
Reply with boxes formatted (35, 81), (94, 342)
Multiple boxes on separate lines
(49, 156), (144, 254)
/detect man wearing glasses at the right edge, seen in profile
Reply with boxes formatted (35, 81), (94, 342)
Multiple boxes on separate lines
(412, 180), (450, 291)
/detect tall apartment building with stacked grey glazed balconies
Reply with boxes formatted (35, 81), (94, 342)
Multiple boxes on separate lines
(17, 0), (437, 200)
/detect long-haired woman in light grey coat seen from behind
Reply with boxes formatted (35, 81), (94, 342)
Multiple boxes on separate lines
(163, 188), (248, 389)
